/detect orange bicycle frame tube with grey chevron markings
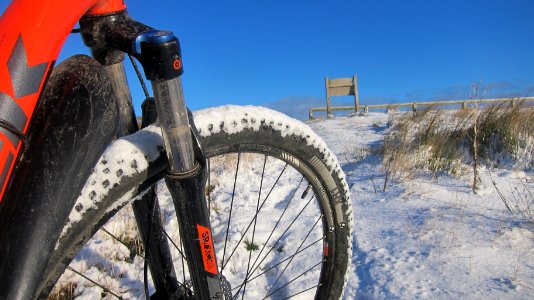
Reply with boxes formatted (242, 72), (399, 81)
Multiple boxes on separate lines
(0, 0), (126, 203)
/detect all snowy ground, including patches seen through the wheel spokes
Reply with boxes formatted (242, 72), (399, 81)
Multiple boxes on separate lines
(56, 109), (534, 299)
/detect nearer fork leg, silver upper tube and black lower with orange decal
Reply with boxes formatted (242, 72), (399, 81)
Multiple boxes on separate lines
(151, 45), (229, 299)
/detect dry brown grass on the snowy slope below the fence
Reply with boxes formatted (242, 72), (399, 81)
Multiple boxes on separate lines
(383, 103), (534, 189)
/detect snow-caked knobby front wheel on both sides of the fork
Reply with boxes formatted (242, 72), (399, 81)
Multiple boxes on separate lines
(43, 106), (352, 299)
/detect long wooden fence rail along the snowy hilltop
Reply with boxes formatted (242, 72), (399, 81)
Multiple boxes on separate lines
(309, 97), (534, 119)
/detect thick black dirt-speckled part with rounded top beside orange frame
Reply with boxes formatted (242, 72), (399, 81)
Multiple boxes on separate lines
(0, 55), (118, 299)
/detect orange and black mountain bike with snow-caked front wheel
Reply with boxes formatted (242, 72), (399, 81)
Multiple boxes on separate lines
(0, 0), (352, 299)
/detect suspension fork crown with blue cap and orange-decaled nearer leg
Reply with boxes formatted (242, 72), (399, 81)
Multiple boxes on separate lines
(80, 11), (229, 299)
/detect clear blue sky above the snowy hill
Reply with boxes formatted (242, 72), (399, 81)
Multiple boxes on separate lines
(0, 0), (534, 119)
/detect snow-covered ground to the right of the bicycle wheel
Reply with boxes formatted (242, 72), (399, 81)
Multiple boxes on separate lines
(310, 113), (534, 299)
